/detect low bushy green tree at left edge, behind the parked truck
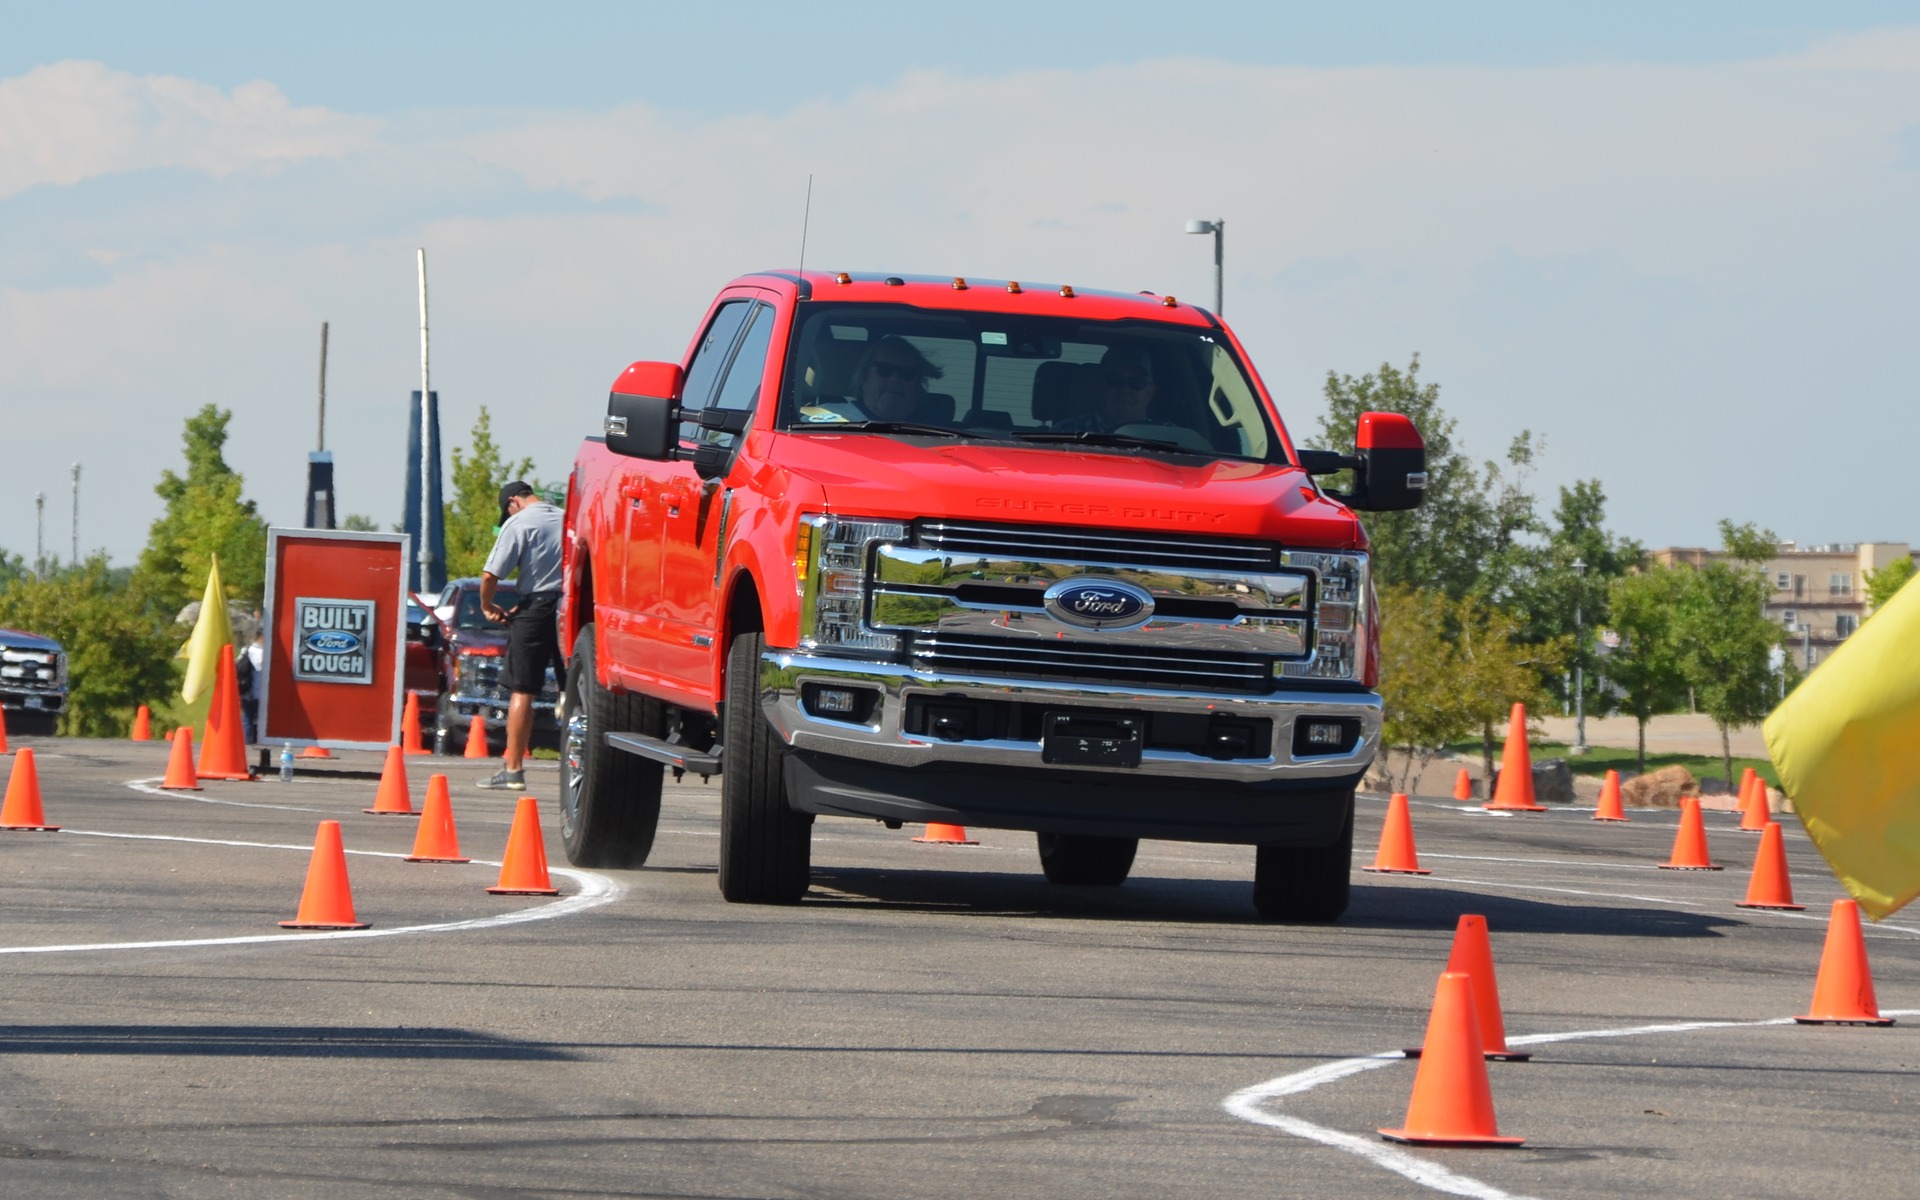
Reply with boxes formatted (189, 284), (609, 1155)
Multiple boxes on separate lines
(0, 553), (179, 737)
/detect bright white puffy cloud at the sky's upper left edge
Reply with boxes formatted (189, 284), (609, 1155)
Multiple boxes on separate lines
(0, 61), (380, 198)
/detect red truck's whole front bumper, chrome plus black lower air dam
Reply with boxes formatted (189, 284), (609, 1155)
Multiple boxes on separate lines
(760, 651), (1380, 845)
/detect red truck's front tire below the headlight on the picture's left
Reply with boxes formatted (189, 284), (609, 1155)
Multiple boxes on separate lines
(720, 634), (814, 904)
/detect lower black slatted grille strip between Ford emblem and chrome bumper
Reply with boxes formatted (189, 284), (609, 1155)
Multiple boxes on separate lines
(910, 634), (1273, 693)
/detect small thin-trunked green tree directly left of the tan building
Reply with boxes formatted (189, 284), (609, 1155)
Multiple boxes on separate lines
(1678, 520), (1786, 787)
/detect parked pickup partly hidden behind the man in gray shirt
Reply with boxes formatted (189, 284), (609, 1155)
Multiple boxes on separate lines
(424, 578), (561, 755)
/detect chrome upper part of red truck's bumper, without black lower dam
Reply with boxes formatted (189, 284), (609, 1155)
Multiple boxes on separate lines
(760, 651), (1380, 783)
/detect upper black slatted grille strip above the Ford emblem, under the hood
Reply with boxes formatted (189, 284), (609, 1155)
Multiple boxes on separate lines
(914, 520), (1279, 570)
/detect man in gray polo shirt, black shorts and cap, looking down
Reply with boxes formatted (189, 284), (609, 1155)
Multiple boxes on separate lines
(480, 480), (566, 791)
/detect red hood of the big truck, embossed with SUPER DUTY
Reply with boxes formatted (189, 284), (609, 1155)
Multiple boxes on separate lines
(776, 434), (1365, 549)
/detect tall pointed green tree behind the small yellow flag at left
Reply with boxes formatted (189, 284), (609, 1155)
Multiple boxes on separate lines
(134, 405), (267, 618)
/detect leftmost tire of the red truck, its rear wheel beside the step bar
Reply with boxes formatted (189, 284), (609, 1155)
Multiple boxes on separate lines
(561, 626), (664, 868)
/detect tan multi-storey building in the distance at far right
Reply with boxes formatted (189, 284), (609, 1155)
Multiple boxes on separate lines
(1647, 541), (1920, 668)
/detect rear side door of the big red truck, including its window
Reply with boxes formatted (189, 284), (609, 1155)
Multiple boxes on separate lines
(601, 300), (755, 691)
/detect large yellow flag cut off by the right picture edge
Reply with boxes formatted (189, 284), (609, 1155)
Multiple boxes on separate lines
(1763, 572), (1920, 922)
